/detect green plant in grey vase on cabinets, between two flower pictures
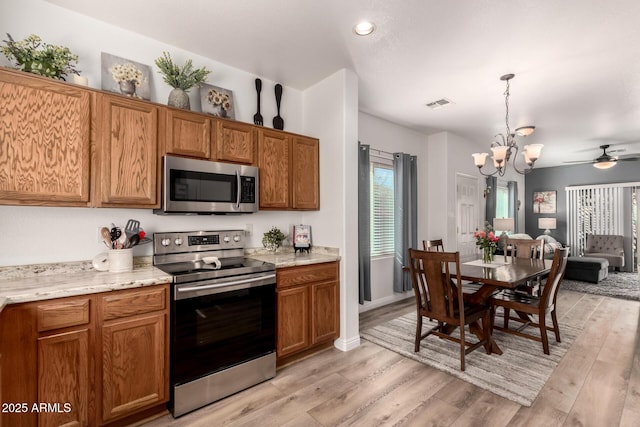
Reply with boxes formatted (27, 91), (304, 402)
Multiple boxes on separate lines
(155, 52), (211, 110)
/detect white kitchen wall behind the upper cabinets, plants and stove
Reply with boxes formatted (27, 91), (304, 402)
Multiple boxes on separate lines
(0, 0), (336, 266)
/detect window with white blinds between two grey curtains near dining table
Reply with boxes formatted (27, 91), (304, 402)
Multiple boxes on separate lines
(370, 162), (394, 257)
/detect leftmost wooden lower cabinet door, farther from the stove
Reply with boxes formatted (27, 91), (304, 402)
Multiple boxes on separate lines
(38, 329), (91, 426)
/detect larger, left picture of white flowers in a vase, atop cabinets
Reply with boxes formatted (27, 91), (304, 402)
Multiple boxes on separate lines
(101, 52), (151, 101)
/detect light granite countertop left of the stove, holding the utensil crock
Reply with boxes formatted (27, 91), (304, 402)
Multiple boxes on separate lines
(0, 257), (172, 311)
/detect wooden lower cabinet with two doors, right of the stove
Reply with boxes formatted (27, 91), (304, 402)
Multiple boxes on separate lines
(276, 261), (340, 365)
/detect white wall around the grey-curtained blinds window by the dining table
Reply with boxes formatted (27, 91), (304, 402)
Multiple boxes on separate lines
(353, 112), (432, 312)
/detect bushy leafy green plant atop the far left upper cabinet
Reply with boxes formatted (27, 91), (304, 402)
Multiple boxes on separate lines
(0, 33), (80, 80)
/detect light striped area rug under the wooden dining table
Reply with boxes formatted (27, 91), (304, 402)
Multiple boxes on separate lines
(360, 313), (580, 406)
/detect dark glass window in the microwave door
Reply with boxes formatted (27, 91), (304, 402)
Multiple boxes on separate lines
(170, 169), (237, 202)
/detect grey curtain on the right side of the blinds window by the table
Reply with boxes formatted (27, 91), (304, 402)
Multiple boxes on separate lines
(393, 153), (418, 292)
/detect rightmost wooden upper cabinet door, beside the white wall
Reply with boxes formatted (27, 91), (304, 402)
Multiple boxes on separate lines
(291, 135), (320, 210)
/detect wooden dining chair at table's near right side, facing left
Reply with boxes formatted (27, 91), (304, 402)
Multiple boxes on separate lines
(489, 248), (569, 354)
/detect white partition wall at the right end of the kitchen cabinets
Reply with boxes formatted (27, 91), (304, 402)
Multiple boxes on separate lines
(303, 70), (360, 351)
